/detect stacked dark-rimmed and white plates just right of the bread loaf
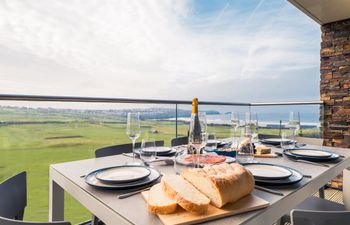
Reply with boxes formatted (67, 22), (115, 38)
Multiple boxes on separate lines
(244, 163), (303, 186)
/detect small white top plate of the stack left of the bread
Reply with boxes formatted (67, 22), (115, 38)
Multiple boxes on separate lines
(96, 166), (151, 183)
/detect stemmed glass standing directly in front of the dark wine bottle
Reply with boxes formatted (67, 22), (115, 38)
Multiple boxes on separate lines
(188, 112), (208, 167)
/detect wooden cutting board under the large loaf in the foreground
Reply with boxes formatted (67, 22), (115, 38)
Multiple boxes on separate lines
(142, 191), (270, 225)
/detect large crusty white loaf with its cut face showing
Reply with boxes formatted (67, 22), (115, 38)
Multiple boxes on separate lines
(181, 163), (254, 208)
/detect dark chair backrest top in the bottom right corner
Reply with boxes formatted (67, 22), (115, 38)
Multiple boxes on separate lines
(290, 209), (350, 225)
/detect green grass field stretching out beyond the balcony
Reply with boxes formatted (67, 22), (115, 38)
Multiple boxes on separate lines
(0, 109), (319, 224)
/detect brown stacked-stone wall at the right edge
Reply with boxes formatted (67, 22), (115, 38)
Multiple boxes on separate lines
(320, 19), (350, 148)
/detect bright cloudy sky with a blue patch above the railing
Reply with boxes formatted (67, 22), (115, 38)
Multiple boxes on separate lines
(0, 0), (320, 102)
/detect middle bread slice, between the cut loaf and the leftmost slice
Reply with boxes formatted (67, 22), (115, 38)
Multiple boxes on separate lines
(162, 175), (210, 214)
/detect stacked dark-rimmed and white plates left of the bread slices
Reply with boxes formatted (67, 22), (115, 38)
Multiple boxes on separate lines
(85, 165), (160, 189)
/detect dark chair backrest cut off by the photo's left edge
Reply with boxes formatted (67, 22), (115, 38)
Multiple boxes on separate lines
(0, 172), (27, 220)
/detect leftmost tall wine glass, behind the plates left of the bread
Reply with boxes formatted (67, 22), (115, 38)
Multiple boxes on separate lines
(126, 112), (141, 164)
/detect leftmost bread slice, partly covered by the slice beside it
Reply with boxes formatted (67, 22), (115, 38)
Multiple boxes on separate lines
(147, 183), (177, 214)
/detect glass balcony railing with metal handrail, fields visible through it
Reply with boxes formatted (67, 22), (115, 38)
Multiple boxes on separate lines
(0, 94), (323, 223)
